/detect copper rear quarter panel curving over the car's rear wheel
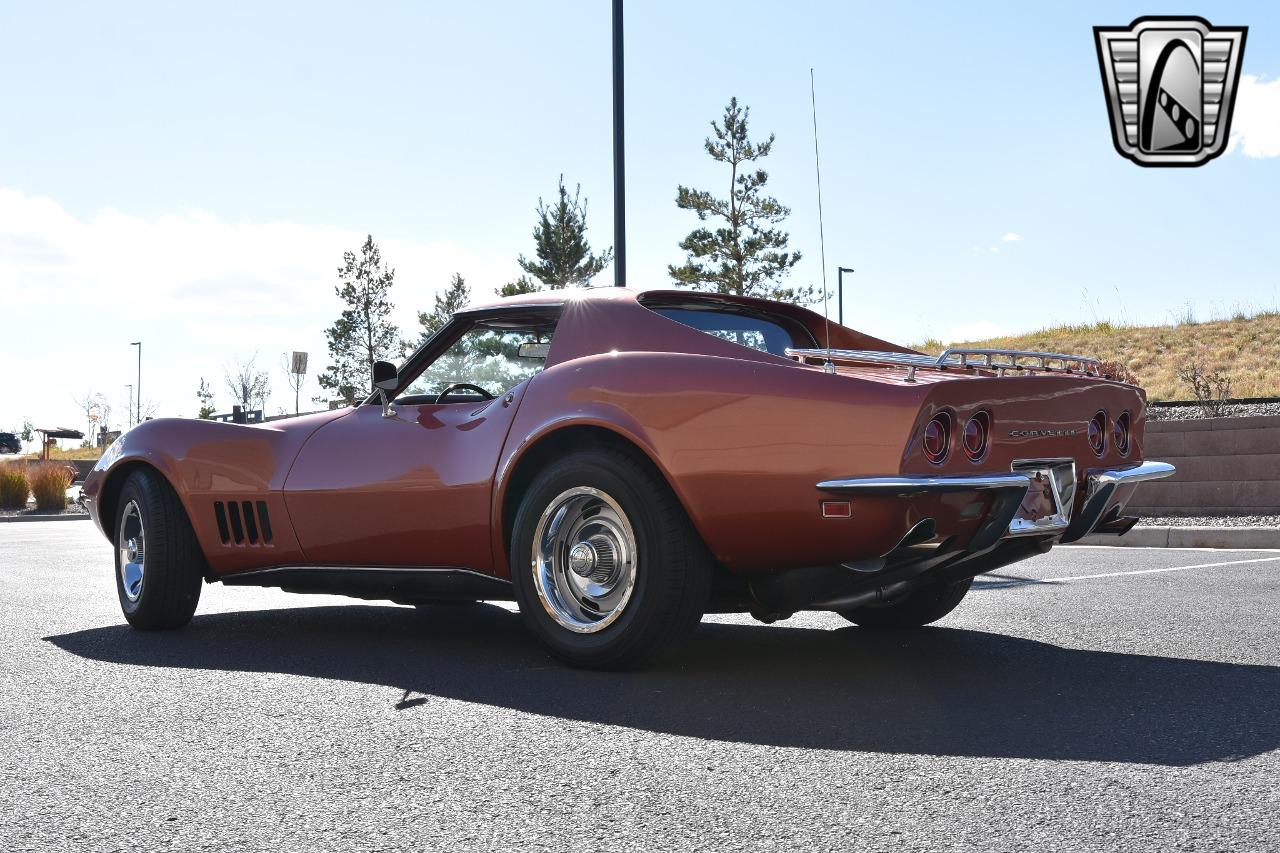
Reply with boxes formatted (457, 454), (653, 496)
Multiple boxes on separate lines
(495, 348), (927, 573)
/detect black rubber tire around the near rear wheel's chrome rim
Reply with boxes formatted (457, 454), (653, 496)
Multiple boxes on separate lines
(511, 447), (712, 669)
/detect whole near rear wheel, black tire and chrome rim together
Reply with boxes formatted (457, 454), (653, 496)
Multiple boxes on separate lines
(511, 440), (712, 669)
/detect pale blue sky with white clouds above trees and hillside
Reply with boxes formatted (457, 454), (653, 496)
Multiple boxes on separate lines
(0, 0), (1280, 428)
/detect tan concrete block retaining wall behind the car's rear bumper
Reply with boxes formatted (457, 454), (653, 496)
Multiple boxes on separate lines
(1125, 415), (1280, 516)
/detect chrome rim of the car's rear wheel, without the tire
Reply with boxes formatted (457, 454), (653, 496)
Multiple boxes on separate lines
(532, 485), (639, 634)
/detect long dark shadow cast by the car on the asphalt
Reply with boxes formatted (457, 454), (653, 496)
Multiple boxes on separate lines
(46, 605), (1280, 766)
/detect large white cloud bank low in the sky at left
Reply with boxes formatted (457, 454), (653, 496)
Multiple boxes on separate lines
(0, 188), (515, 429)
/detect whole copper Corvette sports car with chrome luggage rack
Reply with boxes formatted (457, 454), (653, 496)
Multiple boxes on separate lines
(84, 288), (1172, 667)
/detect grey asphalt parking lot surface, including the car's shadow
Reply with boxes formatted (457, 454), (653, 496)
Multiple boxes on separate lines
(0, 521), (1280, 852)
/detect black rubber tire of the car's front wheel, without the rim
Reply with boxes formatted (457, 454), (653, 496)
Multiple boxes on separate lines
(113, 469), (206, 631)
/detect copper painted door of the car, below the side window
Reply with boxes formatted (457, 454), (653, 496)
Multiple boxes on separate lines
(284, 379), (530, 573)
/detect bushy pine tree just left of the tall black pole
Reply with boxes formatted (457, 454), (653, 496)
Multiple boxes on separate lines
(514, 175), (613, 289)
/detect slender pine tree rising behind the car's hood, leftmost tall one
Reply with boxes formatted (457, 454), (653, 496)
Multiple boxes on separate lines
(317, 234), (399, 406)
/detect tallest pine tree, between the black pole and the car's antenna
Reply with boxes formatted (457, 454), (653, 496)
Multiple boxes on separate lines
(667, 97), (814, 304)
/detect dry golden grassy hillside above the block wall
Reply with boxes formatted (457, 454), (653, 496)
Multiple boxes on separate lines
(916, 311), (1280, 400)
